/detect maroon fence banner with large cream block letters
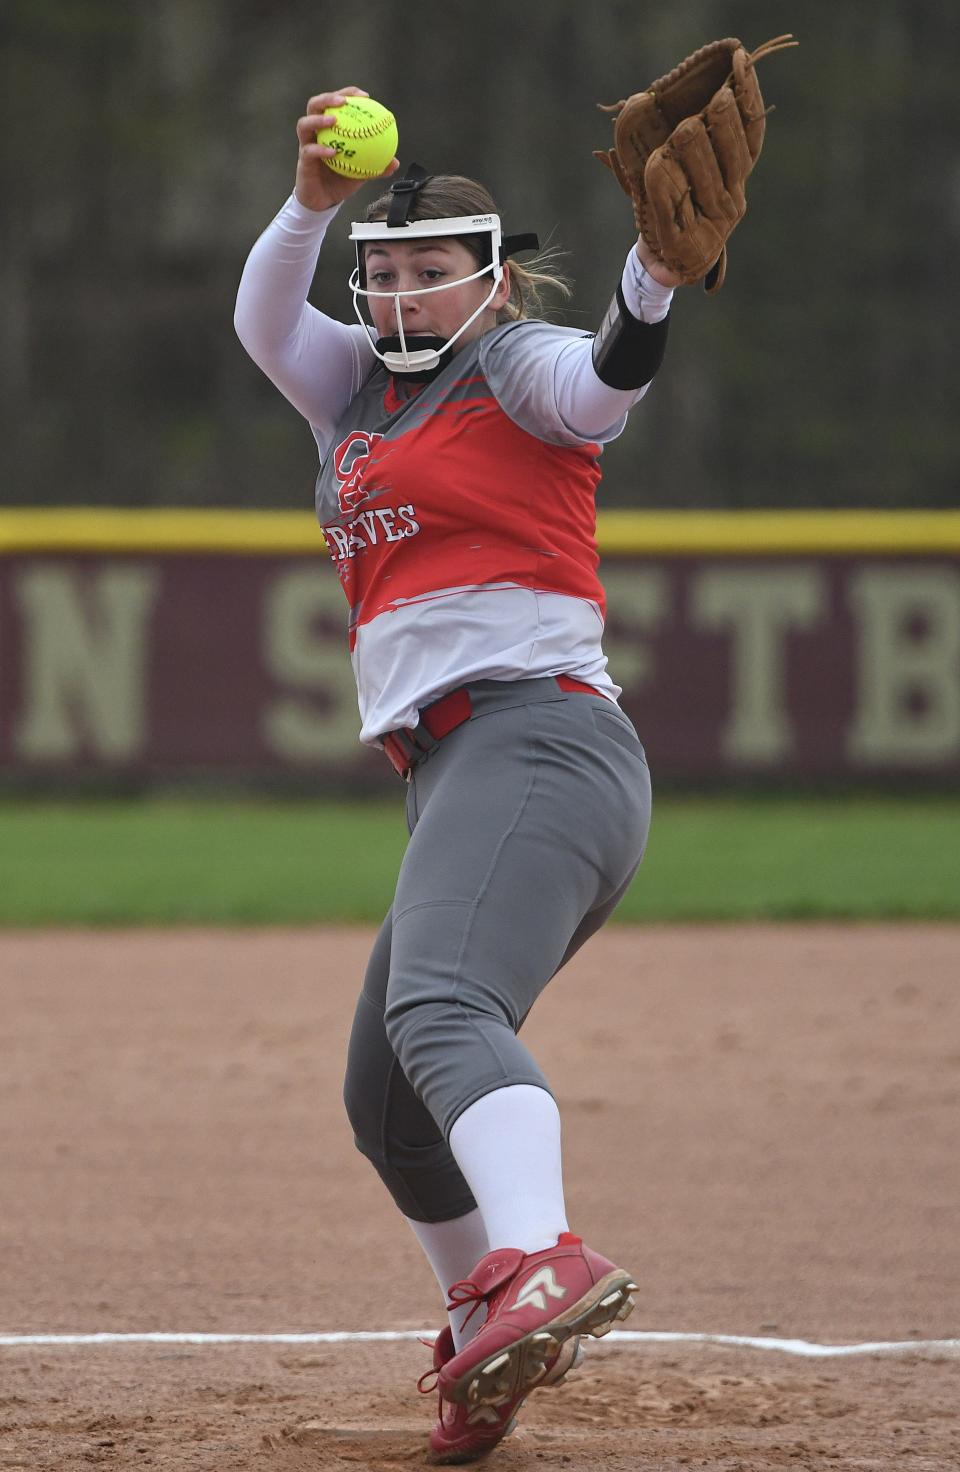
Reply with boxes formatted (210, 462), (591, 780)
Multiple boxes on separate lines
(0, 552), (960, 786)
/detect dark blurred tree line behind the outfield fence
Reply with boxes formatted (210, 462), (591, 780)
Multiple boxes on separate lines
(0, 0), (960, 508)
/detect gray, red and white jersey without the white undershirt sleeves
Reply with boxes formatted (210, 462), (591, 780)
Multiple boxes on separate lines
(317, 321), (626, 743)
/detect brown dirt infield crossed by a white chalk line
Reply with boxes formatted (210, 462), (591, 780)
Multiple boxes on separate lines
(0, 926), (960, 1472)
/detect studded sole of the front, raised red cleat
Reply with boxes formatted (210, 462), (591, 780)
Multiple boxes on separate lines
(443, 1269), (636, 1406)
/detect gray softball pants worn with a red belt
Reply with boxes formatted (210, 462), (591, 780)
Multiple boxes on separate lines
(338, 679), (651, 1222)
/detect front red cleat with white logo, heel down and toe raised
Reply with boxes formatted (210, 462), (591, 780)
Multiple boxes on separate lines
(437, 1232), (636, 1413)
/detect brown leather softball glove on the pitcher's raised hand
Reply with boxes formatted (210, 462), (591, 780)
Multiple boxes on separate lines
(595, 35), (800, 291)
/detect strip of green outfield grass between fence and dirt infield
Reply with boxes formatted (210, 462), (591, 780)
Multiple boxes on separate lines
(0, 798), (960, 926)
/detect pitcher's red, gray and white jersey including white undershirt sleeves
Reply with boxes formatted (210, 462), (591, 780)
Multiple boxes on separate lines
(234, 196), (673, 743)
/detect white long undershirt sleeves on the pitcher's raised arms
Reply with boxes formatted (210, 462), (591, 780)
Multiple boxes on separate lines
(234, 194), (673, 458)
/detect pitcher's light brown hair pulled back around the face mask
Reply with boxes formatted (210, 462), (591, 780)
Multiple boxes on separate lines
(367, 174), (573, 324)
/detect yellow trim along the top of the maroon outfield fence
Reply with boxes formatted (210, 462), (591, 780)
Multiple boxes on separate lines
(0, 506), (960, 556)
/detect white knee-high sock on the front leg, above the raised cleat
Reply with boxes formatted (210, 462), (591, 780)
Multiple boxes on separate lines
(449, 1083), (567, 1253)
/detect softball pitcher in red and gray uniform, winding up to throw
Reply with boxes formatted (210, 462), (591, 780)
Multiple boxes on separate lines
(236, 87), (673, 1462)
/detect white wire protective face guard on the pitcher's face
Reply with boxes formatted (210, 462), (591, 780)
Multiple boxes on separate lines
(349, 215), (504, 374)
